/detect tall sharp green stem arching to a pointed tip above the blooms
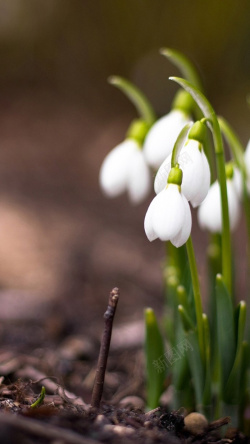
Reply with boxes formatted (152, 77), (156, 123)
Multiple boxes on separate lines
(170, 77), (232, 294)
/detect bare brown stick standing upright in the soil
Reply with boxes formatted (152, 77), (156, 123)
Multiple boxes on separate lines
(91, 288), (119, 408)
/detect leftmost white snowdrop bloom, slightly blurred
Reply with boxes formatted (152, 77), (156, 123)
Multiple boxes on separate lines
(99, 139), (151, 204)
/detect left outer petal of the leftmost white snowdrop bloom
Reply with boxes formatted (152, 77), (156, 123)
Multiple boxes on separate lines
(99, 139), (137, 197)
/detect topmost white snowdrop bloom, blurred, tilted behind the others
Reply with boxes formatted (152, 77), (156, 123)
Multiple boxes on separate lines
(143, 109), (190, 169)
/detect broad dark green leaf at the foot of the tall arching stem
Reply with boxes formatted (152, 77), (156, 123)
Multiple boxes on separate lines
(216, 274), (236, 398)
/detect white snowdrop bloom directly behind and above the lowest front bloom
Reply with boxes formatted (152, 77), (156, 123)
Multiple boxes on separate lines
(154, 139), (210, 207)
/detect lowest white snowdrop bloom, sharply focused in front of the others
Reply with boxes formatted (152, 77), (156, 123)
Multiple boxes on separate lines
(144, 184), (192, 247)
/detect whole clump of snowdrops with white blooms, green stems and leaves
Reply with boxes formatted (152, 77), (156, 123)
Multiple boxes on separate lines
(100, 50), (250, 429)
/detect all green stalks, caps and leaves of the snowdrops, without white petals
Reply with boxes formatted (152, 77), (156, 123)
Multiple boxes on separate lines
(110, 49), (250, 429)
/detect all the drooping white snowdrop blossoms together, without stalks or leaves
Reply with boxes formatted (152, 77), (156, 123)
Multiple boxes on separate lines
(100, 86), (250, 247)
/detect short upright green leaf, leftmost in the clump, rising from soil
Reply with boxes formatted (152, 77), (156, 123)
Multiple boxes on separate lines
(145, 308), (167, 409)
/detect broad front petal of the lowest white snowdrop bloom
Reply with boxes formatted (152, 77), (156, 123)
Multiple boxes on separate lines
(152, 184), (185, 241)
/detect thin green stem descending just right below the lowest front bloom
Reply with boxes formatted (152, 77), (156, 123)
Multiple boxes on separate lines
(186, 236), (205, 362)
